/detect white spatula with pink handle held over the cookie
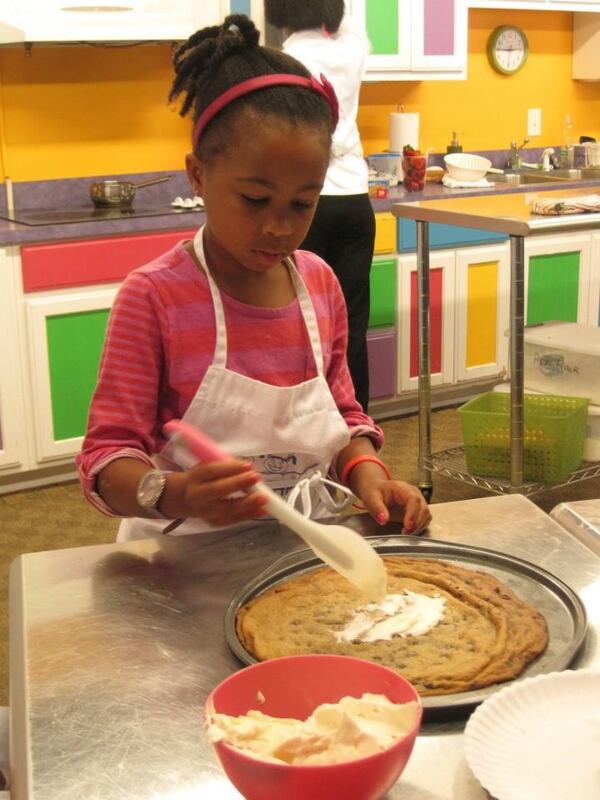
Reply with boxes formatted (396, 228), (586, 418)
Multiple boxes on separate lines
(163, 420), (387, 602)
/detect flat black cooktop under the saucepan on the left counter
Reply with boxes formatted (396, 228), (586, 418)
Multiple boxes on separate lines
(0, 205), (202, 225)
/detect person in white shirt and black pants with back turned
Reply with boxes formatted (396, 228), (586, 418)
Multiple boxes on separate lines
(264, 0), (375, 411)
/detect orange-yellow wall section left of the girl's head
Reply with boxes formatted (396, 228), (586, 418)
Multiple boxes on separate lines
(0, 45), (189, 181)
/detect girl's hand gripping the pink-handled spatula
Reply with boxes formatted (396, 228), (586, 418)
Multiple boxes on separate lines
(160, 460), (268, 527)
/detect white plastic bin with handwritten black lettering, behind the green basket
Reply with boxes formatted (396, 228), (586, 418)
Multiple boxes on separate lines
(524, 322), (600, 405)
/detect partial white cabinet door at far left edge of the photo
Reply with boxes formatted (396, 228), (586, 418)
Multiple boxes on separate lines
(0, 248), (28, 476)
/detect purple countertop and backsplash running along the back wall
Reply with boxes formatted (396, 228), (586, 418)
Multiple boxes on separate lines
(0, 148), (600, 247)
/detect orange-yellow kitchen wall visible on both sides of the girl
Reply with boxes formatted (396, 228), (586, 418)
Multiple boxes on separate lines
(0, 10), (600, 181)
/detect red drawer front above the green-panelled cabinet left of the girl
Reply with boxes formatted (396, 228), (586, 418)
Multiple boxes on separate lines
(21, 230), (196, 292)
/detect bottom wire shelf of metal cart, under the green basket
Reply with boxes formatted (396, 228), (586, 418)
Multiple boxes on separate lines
(424, 447), (600, 496)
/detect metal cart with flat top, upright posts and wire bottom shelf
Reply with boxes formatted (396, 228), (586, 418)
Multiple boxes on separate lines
(392, 189), (600, 500)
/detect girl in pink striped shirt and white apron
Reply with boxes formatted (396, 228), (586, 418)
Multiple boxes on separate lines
(77, 15), (430, 541)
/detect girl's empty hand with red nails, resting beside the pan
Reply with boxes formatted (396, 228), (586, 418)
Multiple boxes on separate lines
(360, 478), (431, 533)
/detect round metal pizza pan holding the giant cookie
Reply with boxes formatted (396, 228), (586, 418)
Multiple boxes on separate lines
(225, 537), (587, 719)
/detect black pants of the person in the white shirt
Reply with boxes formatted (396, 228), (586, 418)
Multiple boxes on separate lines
(301, 194), (375, 411)
